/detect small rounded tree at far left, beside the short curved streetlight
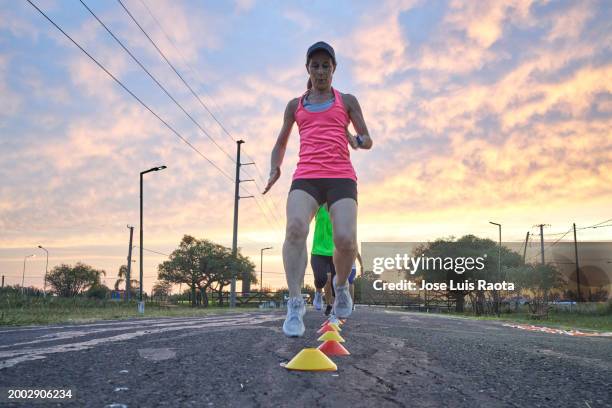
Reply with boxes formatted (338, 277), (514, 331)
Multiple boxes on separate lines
(47, 262), (106, 297)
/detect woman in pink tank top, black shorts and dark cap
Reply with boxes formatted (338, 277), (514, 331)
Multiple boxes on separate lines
(264, 41), (372, 337)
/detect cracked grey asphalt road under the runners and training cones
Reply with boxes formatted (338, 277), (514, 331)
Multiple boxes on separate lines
(0, 307), (612, 408)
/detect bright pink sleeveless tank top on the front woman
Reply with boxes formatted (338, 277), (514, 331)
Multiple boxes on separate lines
(293, 88), (357, 181)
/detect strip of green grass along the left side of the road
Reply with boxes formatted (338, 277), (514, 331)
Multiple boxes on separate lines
(0, 294), (257, 326)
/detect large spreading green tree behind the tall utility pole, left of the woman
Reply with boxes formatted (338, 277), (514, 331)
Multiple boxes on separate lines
(158, 235), (257, 307)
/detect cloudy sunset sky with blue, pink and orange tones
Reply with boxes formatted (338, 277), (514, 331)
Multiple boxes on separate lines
(0, 0), (612, 289)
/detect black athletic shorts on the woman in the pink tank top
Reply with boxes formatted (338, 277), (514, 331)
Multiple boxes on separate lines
(289, 178), (357, 208)
